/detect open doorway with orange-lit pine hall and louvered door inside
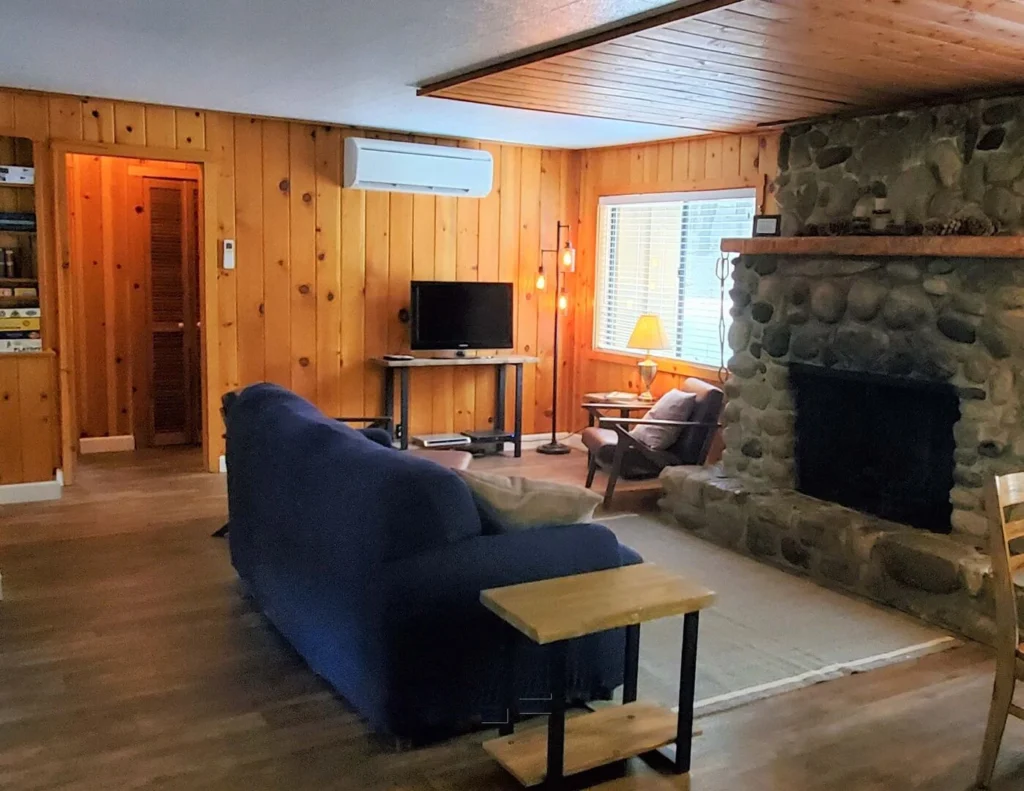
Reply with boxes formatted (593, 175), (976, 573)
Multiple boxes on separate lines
(66, 154), (203, 454)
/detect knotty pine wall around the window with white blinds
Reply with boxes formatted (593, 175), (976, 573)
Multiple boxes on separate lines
(571, 133), (778, 429)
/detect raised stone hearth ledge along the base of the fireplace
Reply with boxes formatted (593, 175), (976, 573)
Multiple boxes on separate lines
(658, 466), (999, 640)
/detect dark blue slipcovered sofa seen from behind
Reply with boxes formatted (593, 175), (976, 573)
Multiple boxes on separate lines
(224, 384), (640, 741)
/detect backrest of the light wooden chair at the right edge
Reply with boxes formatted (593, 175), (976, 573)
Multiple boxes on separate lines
(985, 472), (1024, 662)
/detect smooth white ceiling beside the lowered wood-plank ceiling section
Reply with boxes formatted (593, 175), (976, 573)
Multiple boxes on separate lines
(0, 0), (696, 148)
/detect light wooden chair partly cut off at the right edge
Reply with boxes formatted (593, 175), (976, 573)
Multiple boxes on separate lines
(978, 472), (1024, 788)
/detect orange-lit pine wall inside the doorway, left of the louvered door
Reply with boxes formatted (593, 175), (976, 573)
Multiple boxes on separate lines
(67, 154), (201, 442)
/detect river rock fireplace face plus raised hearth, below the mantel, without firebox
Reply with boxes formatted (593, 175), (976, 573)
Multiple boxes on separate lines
(662, 255), (1024, 637)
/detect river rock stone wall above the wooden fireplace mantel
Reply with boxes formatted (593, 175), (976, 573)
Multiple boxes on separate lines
(776, 96), (1024, 236)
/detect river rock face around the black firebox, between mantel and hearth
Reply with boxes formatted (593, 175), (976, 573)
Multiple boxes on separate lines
(723, 256), (1024, 539)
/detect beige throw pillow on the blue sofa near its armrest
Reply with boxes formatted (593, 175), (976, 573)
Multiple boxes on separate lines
(459, 470), (601, 529)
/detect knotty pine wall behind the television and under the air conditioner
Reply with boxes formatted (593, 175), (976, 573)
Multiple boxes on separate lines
(0, 90), (581, 469)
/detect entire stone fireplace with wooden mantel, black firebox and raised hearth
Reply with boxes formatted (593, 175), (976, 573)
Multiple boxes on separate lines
(660, 91), (1024, 638)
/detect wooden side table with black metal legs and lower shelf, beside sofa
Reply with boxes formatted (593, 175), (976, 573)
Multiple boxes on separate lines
(480, 564), (715, 788)
